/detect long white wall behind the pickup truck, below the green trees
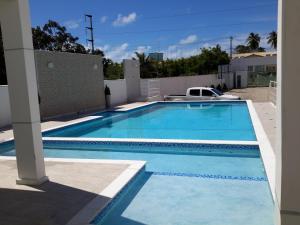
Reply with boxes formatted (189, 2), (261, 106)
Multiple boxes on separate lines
(141, 74), (222, 97)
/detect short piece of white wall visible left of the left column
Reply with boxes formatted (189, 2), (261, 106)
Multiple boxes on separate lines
(0, 85), (11, 127)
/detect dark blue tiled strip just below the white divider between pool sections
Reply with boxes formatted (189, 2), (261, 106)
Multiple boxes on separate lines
(39, 140), (260, 157)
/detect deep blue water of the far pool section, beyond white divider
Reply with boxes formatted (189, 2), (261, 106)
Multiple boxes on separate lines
(44, 102), (256, 141)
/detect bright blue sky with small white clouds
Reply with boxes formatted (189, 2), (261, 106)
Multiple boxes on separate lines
(29, 0), (277, 61)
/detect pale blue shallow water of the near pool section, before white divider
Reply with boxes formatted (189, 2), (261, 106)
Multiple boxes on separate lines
(0, 141), (273, 225)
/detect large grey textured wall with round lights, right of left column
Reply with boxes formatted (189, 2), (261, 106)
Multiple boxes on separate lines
(35, 51), (105, 118)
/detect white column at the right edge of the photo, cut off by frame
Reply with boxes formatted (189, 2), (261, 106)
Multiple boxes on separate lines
(276, 0), (300, 225)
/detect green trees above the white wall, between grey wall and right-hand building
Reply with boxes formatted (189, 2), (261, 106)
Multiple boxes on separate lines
(103, 45), (230, 79)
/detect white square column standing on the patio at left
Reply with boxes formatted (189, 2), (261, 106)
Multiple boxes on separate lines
(0, 0), (48, 185)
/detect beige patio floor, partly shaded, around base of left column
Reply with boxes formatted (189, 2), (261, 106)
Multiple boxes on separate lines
(0, 160), (129, 225)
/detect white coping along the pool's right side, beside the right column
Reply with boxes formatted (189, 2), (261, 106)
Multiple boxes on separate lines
(246, 100), (276, 202)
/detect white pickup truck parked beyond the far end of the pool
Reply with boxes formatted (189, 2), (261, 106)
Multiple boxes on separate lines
(164, 87), (241, 101)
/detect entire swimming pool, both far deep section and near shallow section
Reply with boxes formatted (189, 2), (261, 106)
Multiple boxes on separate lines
(0, 101), (274, 225)
